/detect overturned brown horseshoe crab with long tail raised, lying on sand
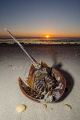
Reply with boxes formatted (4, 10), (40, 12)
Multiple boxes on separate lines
(6, 30), (66, 102)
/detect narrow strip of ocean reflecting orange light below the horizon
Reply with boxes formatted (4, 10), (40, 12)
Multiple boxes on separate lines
(0, 37), (80, 44)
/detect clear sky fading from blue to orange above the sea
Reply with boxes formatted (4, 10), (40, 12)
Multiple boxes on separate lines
(0, 0), (80, 37)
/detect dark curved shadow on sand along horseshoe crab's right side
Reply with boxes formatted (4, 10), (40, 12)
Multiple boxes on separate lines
(52, 63), (74, 102)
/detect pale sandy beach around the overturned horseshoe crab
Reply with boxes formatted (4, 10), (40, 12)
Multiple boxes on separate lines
(0, 44), (80, 120)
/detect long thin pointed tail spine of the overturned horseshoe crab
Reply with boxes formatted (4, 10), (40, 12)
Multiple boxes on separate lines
(5, 28), (38, 64)
